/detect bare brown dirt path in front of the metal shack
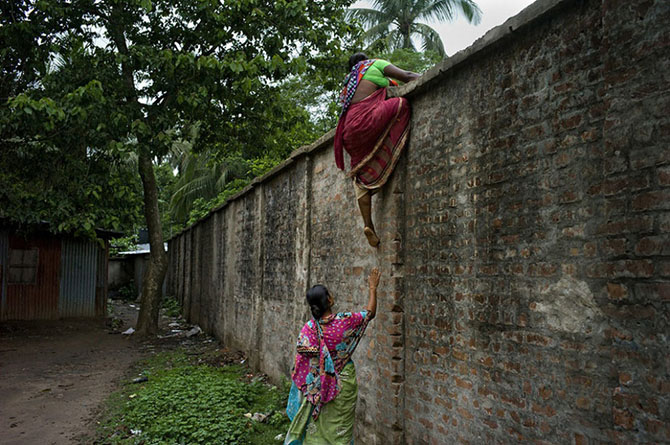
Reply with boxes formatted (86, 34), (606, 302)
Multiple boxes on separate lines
(0, 305), (147, 445)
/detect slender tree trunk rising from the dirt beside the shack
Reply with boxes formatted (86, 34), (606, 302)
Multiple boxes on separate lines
(136, 153), (168, 335)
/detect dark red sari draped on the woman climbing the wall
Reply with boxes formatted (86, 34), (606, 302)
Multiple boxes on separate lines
(335, 88), (410, 190)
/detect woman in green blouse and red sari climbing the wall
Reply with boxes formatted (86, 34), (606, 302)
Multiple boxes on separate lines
(335, 53), (419, 247)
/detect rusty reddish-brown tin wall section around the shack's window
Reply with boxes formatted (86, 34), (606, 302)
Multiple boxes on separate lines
(2, 234), (61, 320)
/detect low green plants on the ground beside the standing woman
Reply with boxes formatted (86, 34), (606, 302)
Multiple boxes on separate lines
(96, 351), (288, 445)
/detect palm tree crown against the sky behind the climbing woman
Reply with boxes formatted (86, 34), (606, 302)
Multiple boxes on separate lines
(349, 0), (482, 57)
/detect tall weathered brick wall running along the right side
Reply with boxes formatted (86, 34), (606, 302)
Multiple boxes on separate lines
(168, 0), (670, 445)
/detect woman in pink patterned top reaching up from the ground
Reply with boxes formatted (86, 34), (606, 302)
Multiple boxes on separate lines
(284, 268), (380, 445)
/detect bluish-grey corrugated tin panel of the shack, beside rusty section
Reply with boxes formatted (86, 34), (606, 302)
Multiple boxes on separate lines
(58, 239), (101, 317)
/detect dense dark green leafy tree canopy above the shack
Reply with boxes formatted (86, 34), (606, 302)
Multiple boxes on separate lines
(0, 0), (350, 235)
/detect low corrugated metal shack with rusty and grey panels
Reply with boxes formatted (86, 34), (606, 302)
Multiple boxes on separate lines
(0, 223), (118, 321)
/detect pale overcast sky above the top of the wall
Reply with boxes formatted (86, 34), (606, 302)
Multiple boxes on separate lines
(353, 0), (533, 56)
